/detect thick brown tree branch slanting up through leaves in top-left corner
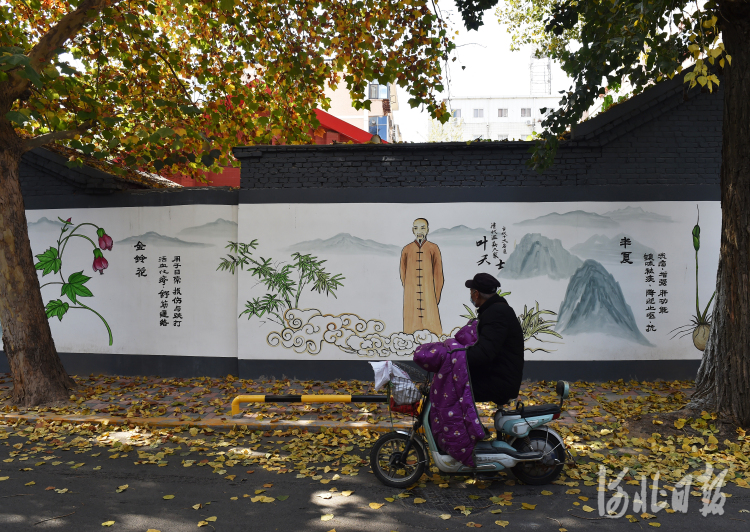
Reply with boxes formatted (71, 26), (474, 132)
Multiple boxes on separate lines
(6, 0), (119, 100)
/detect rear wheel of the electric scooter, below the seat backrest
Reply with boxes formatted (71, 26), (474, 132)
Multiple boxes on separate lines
(511, 430), (565, 486)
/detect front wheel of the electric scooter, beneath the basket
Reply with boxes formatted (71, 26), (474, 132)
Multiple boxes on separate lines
(370, 432), (427, 489)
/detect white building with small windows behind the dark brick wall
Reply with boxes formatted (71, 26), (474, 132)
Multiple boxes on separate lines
(446, 95), (560, 141)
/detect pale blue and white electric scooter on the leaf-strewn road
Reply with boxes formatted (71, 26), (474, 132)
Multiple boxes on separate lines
(370, 372), (572, 489)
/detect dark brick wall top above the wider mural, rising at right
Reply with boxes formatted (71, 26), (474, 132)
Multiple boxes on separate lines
(234, 80), (723, 191)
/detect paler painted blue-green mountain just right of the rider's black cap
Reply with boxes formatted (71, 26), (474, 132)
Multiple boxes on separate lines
(499, 233), (583, 279)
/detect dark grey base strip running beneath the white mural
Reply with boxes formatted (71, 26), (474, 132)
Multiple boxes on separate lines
(0, 351), (700, 382)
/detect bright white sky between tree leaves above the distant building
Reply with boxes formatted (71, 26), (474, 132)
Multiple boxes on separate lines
(393, 9), (570, 142)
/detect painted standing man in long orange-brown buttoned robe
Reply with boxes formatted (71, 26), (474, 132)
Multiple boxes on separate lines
(401, 218), (443, 336)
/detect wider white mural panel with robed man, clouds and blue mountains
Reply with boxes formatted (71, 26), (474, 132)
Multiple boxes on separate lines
(238, 202), (721, 360)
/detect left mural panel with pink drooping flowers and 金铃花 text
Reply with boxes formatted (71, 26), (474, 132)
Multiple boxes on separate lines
(26, 205), (237, 357)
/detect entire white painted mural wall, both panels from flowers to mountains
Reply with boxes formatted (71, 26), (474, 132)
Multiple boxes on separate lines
(27, 202), (721, 360)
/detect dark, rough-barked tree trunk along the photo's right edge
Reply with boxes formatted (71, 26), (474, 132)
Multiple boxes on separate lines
(688, 1), (750, 426)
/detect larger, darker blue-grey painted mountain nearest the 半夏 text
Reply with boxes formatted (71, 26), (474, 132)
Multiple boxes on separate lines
(555, 260), (652, 346)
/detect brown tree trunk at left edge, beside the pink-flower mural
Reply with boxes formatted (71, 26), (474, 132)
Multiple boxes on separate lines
(0, 117), (75, 406)
